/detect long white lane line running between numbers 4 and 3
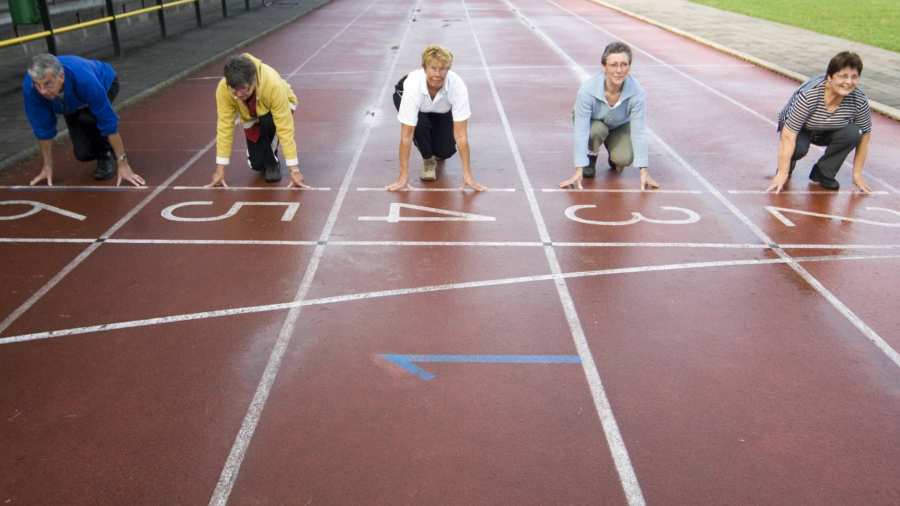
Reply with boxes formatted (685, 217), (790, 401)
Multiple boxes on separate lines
(462, 0), (646, 506)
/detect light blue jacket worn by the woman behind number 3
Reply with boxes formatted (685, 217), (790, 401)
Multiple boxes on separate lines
(574, 72), (647, 167)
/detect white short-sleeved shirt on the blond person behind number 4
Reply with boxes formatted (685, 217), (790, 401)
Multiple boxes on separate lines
(397, 69), (472, 126)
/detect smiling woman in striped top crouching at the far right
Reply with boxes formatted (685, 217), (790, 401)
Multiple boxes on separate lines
(767, 51), (872, 193)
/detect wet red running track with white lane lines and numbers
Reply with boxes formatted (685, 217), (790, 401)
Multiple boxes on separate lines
(0, 0), (900, 505)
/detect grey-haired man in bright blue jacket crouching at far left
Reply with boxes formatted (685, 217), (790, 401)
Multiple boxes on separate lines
(22, 54), (146, 186)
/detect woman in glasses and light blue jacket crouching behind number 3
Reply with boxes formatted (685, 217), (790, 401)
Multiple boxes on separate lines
(559, 42), (659, 190)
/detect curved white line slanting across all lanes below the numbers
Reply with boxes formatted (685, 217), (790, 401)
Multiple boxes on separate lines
(0, 254), (900, 345)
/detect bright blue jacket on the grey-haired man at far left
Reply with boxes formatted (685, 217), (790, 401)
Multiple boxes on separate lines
(22, 56), (119, 140)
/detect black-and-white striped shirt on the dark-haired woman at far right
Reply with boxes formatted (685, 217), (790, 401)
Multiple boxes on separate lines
(778, 74), (872, 134)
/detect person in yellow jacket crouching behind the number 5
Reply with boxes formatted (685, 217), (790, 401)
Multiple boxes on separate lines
(206, 53), (309, 188)
